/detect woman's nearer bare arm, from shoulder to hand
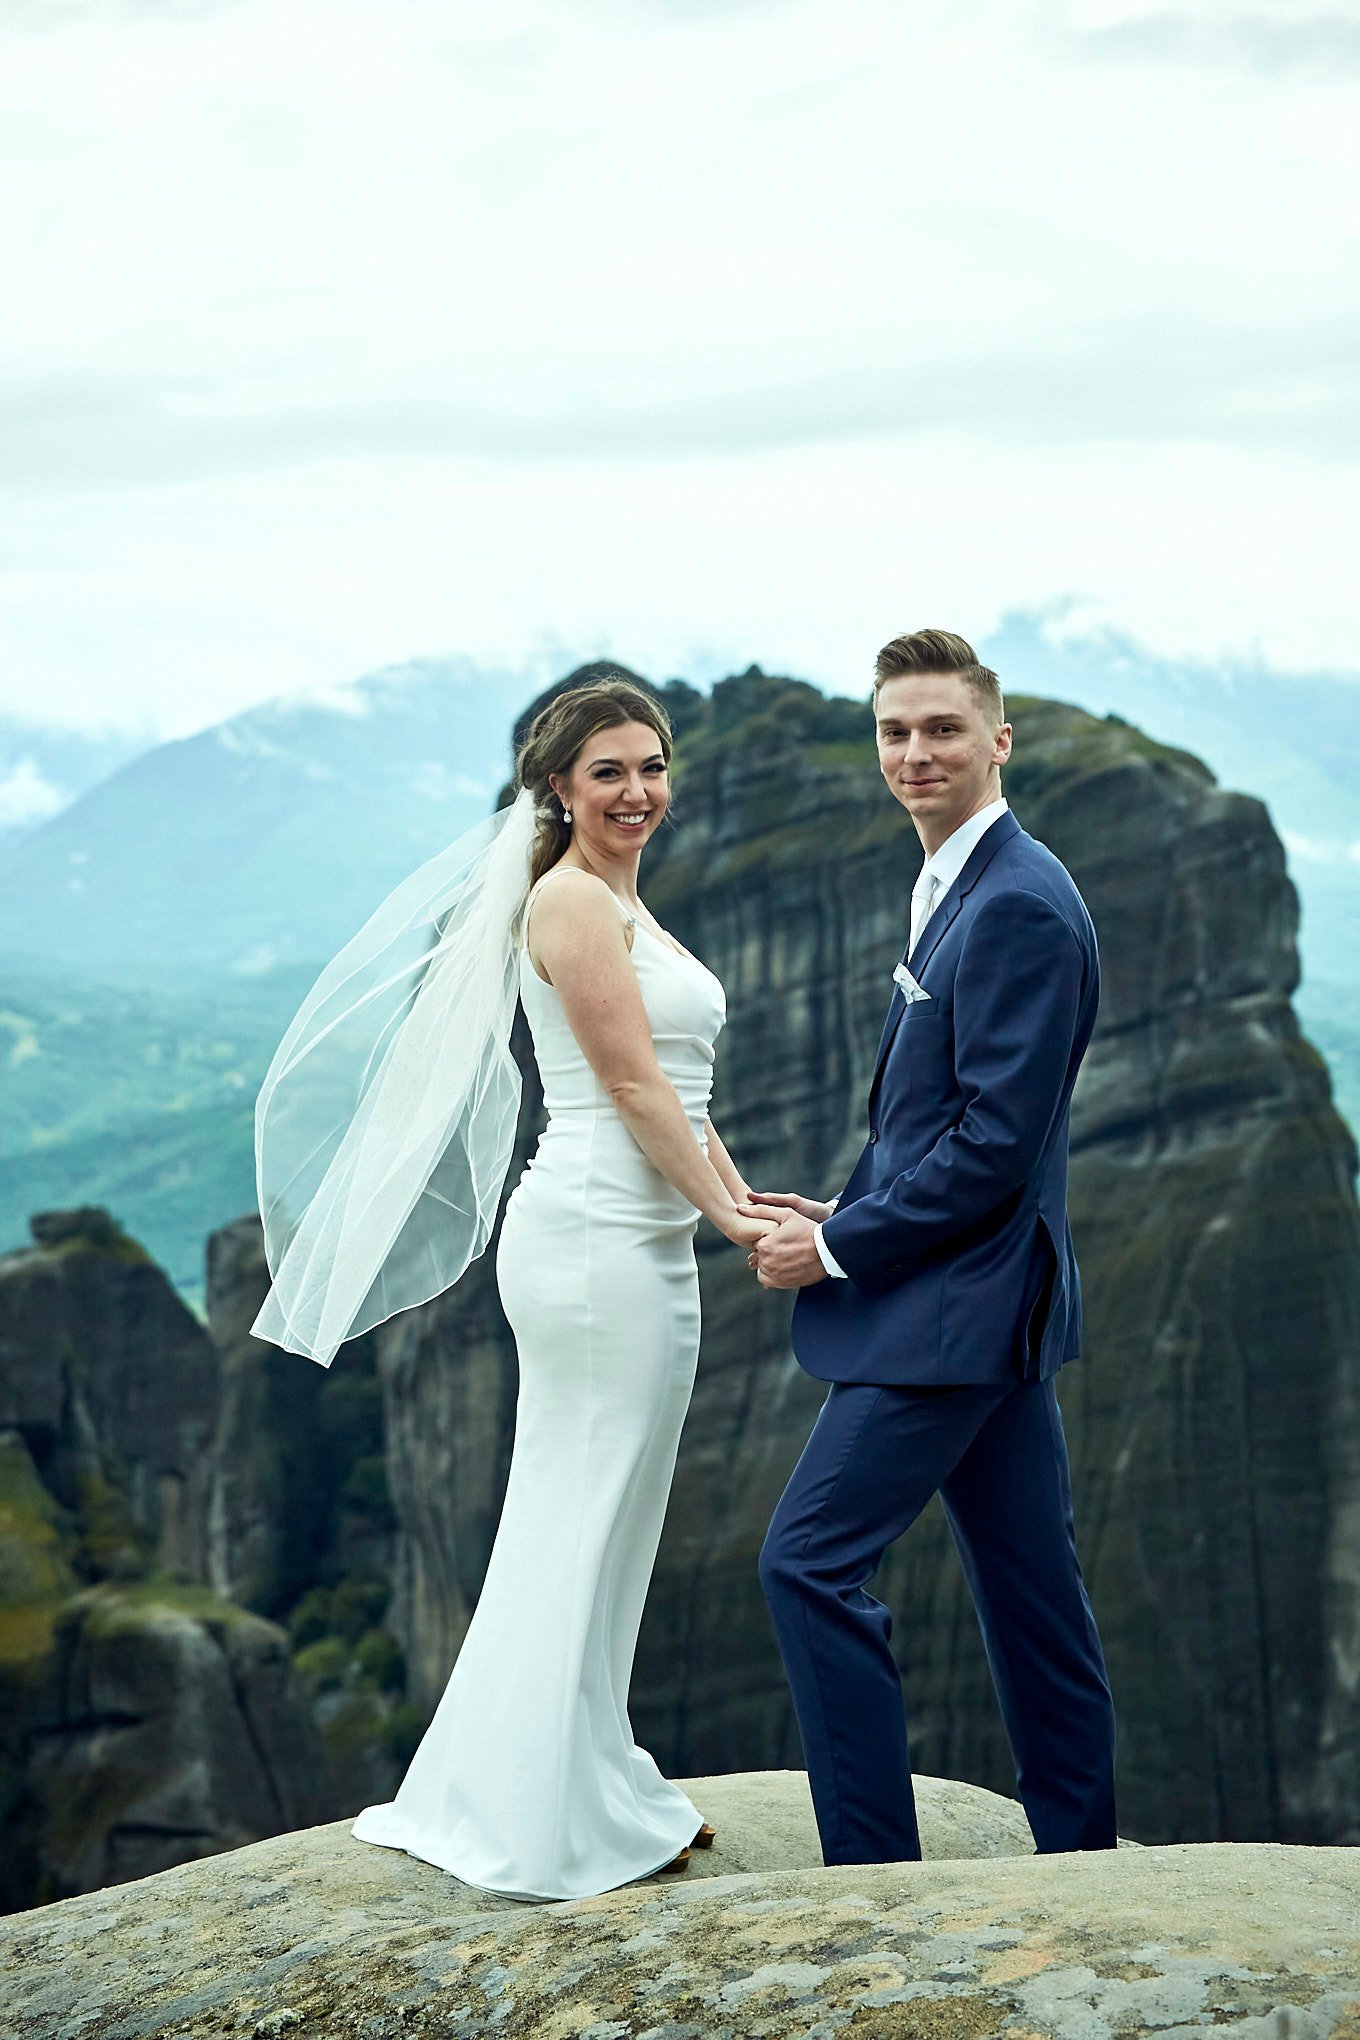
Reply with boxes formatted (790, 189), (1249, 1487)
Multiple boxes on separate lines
(528, 871), (773, 1246)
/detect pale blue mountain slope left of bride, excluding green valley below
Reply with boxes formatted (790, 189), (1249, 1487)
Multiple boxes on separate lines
(0, 659), (532, 981)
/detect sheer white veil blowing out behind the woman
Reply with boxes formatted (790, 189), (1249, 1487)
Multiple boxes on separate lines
(251, 787), (536, 1367)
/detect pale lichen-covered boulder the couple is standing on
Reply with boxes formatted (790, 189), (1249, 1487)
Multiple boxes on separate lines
(0, 1773), (1360, 2040)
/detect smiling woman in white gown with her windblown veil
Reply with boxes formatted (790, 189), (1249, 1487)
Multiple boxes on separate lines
(255, 675), (773, 1899)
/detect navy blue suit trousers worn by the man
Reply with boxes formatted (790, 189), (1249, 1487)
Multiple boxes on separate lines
(761, 1381), (1115, 1863)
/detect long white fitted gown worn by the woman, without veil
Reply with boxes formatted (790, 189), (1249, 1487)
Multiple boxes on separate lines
(353, 873), (726, 1899)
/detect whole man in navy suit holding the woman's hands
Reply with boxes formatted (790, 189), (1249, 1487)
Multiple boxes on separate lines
(748, 630), (1115, 1863)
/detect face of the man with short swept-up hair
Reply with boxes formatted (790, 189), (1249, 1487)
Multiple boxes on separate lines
(875, 673), (1011, 855)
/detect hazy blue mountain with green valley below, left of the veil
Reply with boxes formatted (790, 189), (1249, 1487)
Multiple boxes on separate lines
(0, 659), (534, 1297)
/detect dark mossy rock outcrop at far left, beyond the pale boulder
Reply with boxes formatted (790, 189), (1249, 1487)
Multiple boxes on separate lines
(0, 1212), (334, 1909)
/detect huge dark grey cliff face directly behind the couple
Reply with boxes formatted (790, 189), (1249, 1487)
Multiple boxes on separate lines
(322, 675), (1360, 1840)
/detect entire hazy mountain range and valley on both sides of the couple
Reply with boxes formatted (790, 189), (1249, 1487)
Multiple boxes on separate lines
(0, 618), (1360, 1297)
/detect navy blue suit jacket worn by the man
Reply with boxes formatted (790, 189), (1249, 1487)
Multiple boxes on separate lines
(793, 812), (1099, 1385)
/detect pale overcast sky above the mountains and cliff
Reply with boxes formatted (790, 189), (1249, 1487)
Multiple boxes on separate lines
(0, 0), (1360, 734)
